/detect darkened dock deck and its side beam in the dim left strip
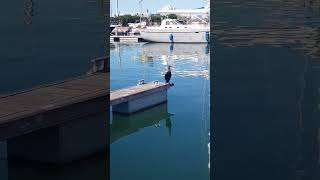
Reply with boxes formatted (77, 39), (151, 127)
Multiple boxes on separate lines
(0, 73), (110, 139)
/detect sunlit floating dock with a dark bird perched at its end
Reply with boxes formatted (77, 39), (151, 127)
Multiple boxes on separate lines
(110, 81), (172, 114)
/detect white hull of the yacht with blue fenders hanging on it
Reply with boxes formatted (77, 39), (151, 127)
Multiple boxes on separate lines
(140, 30), (210, 43)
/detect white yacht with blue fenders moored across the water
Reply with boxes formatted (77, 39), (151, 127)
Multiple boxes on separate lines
(140, 19), (210, 43)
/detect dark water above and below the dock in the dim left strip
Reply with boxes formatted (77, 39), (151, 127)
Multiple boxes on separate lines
(0, 0), (108, 180)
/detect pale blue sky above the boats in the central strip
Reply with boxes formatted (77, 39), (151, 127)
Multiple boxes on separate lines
(111, 0), (207, 14)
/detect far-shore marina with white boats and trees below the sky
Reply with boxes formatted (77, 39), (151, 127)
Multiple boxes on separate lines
(110, 1), (210, 43)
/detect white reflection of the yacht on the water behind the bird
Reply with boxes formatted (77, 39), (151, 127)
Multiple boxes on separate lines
(139, 43), (210, 80)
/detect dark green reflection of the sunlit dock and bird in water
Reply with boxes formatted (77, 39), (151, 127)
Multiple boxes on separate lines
(110, 103), (173, 143)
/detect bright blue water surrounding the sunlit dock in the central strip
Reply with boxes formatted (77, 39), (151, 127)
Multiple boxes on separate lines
(110, 43), (210, 180)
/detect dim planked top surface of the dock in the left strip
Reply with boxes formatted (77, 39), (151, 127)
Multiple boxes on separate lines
(0, 73), (109, 125)
